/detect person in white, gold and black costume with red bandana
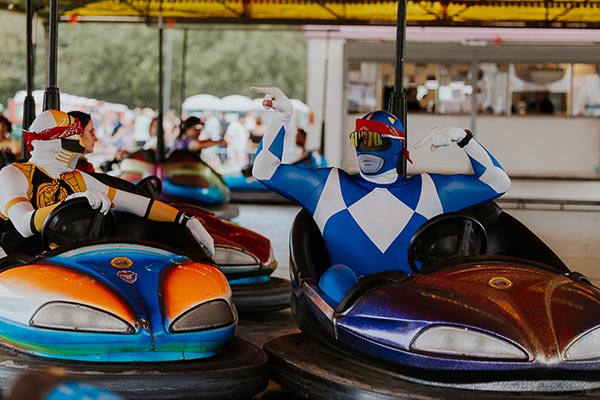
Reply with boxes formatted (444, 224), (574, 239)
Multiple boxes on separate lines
(0, 110), (214, 257)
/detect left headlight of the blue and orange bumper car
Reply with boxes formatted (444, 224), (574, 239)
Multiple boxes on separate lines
(29, 301), (135, 333)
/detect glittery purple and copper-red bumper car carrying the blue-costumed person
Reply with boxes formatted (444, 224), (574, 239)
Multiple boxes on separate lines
(263, 202), (600, 399)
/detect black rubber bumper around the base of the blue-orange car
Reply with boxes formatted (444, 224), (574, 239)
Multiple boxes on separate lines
(0, 338), (269, 400)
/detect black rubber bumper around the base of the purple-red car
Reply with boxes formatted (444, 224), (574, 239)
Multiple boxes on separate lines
(263, 333), (600, 400)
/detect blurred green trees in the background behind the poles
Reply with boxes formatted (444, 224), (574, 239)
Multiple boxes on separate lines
(0, 12), (306, 109)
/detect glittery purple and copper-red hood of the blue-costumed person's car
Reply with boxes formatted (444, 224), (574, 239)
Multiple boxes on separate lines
(335, 262), (600, 365)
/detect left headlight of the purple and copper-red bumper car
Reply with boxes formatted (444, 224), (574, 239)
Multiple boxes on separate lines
(411, 325), (528, 361)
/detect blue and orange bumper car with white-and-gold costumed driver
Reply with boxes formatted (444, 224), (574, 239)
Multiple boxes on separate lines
(0, 199), (268, 399)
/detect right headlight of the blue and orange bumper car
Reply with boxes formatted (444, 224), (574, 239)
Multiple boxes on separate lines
(169, 300), (235, 333)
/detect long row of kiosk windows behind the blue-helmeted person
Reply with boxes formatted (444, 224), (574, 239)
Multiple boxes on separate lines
(346, 63), (600, 117)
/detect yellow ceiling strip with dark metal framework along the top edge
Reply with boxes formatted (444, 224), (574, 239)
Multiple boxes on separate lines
(0, 0), (600, 28)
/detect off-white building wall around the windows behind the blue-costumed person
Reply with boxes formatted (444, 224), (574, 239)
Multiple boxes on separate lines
(307, 27), (600, 178)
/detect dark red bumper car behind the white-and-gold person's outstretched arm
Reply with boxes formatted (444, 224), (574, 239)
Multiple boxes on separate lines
(93, 173), (291, 313)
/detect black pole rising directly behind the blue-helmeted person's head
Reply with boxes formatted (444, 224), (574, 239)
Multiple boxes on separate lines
(388, 0), (408, 176)
